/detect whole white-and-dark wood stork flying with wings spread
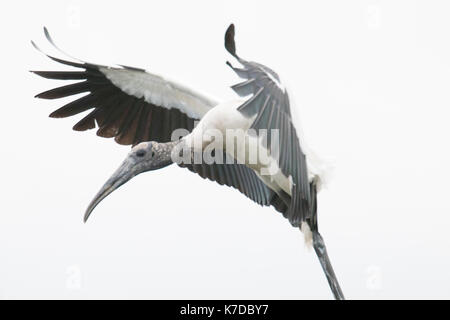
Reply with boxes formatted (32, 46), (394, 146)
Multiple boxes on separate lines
(32, 24), (344, 299)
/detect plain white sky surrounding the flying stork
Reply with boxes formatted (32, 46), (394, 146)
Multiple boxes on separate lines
(0, 0), (450, 299)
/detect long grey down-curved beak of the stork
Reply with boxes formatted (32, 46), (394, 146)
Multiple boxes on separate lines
(84, 158), (139, 222)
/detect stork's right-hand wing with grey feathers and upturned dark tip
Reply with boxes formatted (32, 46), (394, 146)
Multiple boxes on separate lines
(225, 25), (311, 226)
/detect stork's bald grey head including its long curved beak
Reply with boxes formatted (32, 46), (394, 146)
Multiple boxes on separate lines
(84, 142), (172, 222)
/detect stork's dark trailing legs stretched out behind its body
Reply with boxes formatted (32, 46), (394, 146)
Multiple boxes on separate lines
(308, 183), (345, 300)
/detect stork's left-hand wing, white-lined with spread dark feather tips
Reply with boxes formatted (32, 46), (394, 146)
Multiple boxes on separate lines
(32, 29), (217, 145)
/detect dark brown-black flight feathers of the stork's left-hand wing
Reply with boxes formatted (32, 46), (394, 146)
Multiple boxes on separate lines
(31, 28), (198, 145)
